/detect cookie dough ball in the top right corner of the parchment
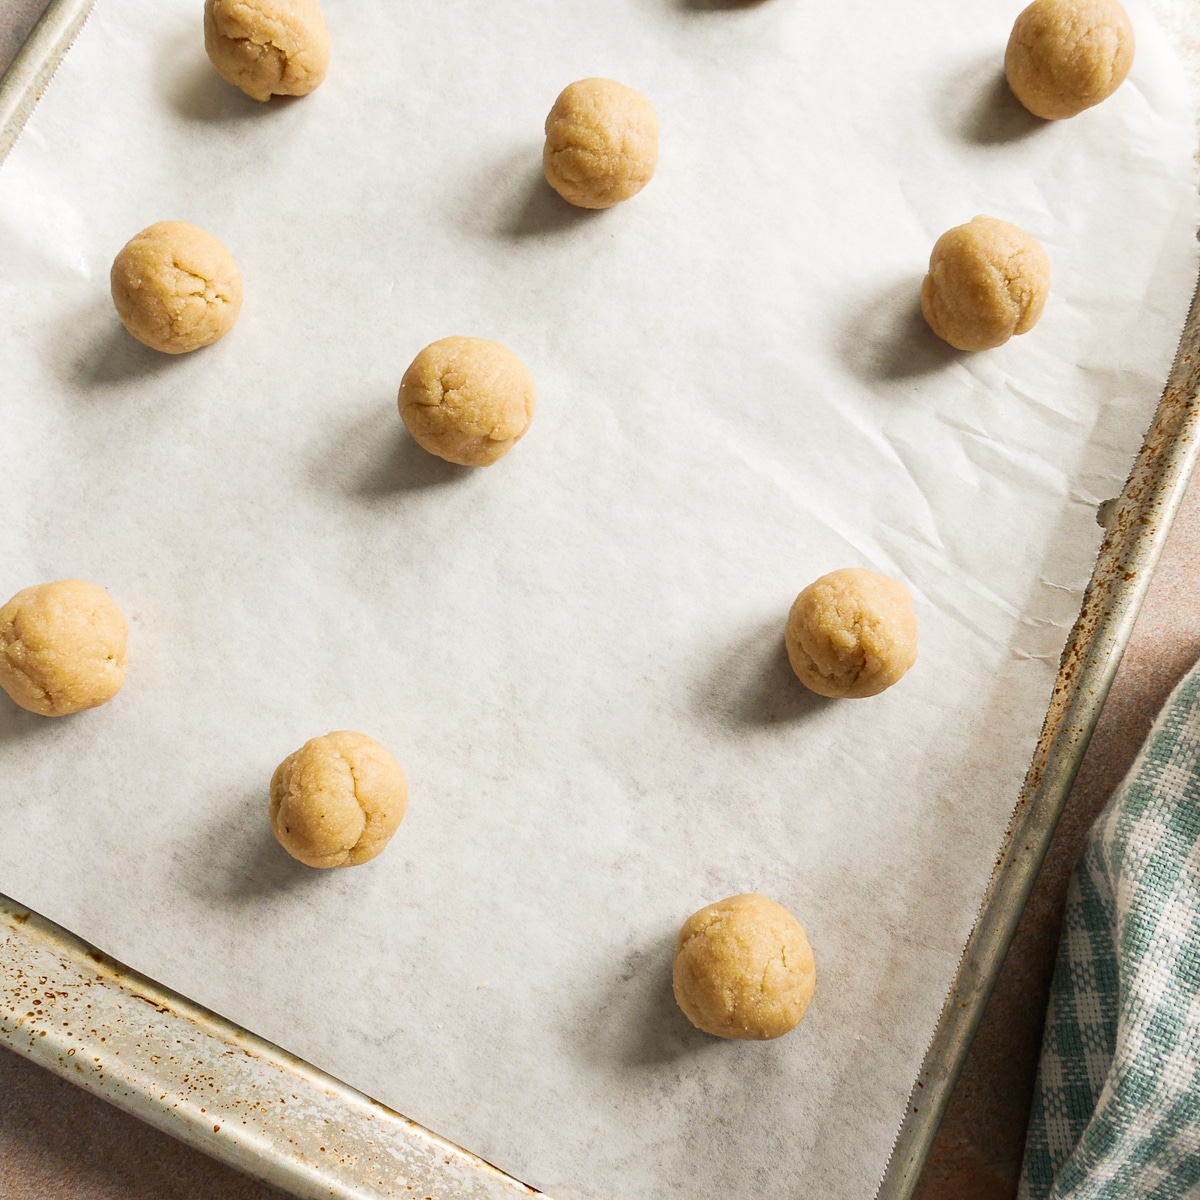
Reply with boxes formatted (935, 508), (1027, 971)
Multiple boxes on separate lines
(1004, 0), (1134, 121)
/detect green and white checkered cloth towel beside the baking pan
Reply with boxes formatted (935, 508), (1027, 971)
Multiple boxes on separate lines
(1019, 666), (1200, 1200)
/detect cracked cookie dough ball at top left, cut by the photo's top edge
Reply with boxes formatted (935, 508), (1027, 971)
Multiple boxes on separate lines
(204, 0), (329, 101)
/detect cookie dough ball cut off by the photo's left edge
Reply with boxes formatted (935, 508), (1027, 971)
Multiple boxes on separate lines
(0, 580), (130, 716)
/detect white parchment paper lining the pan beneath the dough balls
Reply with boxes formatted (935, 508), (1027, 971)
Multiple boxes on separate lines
(0, 0), (1198, 1200)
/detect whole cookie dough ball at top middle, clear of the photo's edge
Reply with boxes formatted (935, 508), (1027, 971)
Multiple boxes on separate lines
(541, 79), (659, 209)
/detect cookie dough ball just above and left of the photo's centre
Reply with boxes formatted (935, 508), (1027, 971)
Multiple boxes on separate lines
(400, 337), (536, 467)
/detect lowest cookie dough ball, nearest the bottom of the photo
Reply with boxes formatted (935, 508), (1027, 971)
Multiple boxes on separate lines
(673, 893), (817, 1042)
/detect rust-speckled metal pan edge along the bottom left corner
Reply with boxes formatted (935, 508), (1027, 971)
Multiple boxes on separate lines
(0, 895), (540, 1200)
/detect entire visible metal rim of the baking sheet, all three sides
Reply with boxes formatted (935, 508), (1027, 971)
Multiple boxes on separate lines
(0, 0), (1200, 1200)
